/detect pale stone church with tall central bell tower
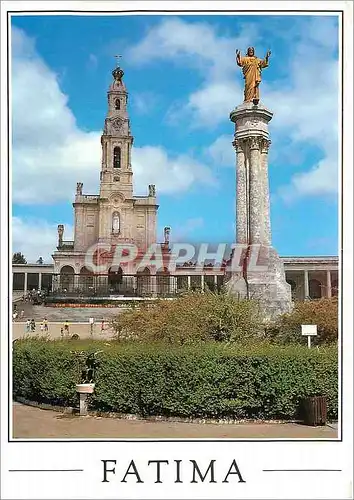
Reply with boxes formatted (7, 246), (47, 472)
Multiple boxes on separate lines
(53, 67), (158, 280)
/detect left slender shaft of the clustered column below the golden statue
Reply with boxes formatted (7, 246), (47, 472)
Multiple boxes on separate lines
(233, 140), (248, 243)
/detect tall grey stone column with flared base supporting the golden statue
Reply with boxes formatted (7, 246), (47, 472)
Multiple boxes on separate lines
(227, 103), (292, 319)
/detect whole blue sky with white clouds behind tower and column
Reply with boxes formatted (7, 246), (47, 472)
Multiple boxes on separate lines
(12, 15), (338, 262)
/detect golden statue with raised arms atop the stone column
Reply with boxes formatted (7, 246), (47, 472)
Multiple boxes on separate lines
(236, 47), (271, 105)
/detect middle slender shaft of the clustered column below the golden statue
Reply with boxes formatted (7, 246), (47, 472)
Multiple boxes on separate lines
(247, 137), (263, 244)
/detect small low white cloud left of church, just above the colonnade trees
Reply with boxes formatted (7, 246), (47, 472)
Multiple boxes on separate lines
(12, 217), (73, 264)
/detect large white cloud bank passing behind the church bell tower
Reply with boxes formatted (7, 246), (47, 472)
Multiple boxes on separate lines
(12, 28), (211, 204)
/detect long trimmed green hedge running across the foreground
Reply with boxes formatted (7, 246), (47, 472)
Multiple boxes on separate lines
(13, 339), (338, 419)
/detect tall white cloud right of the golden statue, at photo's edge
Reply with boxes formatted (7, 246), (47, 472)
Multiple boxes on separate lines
(265, 19), (338, 200)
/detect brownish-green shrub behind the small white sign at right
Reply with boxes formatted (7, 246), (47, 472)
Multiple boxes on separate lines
(269, 297), (338, 345)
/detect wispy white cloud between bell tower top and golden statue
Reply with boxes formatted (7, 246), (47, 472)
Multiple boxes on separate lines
(128, 18), (258, 127)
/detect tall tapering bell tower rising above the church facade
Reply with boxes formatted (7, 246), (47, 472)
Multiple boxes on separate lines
(100, 60), (133, 199)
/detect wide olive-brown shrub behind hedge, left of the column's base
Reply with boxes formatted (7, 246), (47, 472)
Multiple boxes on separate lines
(112, 291), (263, 344)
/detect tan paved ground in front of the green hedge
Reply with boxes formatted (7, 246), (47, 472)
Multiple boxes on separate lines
(13, 403), (337, 439)
